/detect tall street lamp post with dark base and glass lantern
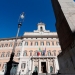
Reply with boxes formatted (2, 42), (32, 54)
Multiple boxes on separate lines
(5, 12), (24, 75)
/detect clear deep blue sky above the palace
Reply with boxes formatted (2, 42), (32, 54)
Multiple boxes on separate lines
(0, 0), (56, 38)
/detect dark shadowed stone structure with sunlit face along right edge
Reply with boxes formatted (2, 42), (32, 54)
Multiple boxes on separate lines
(51, 0), (75, 75)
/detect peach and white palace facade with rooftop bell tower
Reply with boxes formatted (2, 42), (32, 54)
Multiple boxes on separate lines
(0, 22), (61, 75)
